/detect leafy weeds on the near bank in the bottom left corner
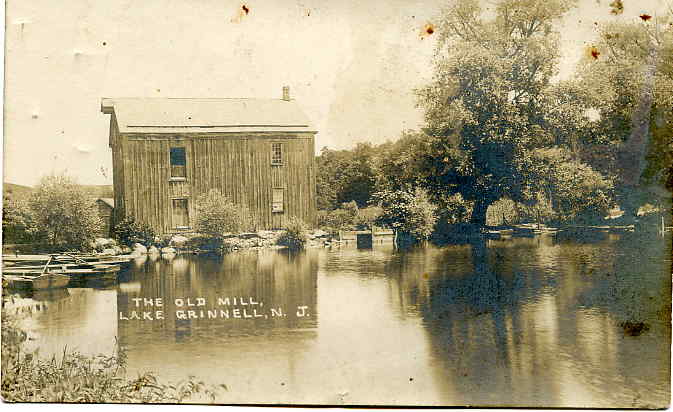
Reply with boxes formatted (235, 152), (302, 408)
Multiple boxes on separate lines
(1, 313), (227, 403)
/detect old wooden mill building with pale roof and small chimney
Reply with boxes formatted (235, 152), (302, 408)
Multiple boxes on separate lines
(101, 87), (316, 233)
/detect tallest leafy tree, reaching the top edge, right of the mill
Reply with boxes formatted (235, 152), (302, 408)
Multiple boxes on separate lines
(419, 0), (581, 225)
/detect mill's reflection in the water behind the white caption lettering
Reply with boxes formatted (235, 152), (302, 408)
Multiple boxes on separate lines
(119, 251), (318, 392)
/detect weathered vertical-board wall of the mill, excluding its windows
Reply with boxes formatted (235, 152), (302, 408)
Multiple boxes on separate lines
(111, 130), (316, 233)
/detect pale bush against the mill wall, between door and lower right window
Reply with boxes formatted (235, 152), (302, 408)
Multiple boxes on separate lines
(195, 189), (253, 238)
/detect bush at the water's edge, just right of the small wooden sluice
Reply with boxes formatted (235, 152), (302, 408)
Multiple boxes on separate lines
(374, 188), (437, 241)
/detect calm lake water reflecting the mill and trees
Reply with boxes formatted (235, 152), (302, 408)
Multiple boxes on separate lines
(6, 234), (671, 407)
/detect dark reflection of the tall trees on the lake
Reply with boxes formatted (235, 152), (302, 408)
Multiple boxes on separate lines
(399, 238), (670, 406)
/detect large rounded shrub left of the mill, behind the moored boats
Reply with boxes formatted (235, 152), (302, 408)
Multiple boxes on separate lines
(27, 175), (102, 250)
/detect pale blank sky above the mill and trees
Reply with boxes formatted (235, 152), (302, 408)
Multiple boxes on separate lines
(3, 0), (673, 186)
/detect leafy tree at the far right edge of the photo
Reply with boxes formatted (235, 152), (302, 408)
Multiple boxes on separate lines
(580, 9), (673, 216)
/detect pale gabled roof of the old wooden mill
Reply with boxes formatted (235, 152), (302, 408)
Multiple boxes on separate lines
(101, 98), (315, 133)
